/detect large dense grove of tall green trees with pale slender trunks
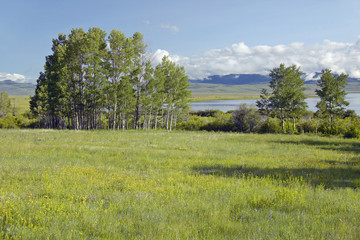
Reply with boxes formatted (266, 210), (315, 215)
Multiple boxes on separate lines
(30, 28), (190, 130)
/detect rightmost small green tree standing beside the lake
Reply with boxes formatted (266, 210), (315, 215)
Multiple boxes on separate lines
(315, 69), (349, 131)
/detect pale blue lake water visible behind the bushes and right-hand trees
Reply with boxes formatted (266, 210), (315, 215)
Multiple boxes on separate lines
(189, 93), (360, 115)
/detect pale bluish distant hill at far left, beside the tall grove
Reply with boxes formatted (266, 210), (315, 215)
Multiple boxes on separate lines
(0, 80), (35, 96)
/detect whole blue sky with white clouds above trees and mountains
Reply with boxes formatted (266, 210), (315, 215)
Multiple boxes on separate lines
(0, 0), (360, 83)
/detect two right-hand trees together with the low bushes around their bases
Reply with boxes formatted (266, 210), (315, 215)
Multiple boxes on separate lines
(180, 64), (360, 138)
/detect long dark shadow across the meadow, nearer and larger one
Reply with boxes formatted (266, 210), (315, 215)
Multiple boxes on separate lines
(192, 165), (360, 188)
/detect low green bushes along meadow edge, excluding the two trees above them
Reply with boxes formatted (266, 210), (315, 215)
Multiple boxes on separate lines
(178, 104), (360, 138)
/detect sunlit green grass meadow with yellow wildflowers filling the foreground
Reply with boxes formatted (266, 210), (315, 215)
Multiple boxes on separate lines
(0, 130), (360, 239)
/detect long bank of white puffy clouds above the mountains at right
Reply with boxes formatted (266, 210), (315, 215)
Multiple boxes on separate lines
(155, 37), (360, 79)
